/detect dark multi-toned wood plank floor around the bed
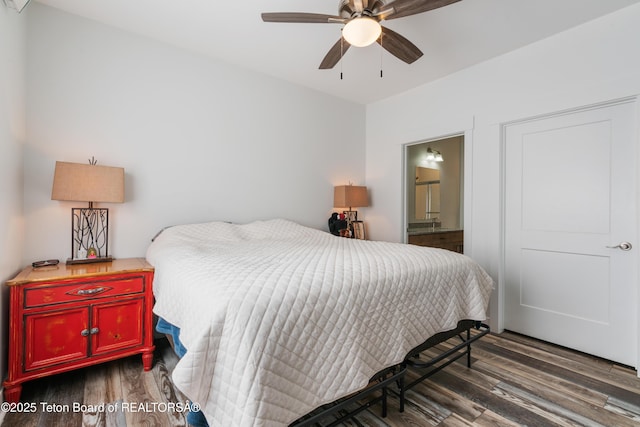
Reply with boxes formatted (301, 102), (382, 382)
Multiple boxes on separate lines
(0, 332), (640, 427)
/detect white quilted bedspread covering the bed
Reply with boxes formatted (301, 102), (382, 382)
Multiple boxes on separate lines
(147, 219), (493, 427)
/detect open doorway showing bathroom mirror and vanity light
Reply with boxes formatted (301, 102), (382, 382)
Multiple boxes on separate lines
(404, 135), (464, 253)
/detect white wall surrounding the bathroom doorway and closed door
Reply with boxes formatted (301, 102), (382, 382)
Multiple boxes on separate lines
(366, 5), (640, 334)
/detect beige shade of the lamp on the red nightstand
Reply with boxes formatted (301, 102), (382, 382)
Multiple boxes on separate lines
(51, 162), (124, 203)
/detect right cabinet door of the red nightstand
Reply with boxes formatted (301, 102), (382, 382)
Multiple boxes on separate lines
(91, 297), (144, 355)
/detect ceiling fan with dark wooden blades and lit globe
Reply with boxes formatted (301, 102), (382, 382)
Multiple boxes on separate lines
(262, 0), (460, 70)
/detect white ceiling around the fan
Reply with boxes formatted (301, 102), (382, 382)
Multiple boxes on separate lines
(36, 0), (640, 104)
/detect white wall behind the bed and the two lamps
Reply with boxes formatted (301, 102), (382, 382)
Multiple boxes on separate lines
(23, 3), (365, 262)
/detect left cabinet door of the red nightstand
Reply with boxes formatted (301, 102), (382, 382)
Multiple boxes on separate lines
(24, 307), (89, 371)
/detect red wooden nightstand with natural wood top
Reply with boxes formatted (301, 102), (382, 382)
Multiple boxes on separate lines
(4, 258), (154, 402)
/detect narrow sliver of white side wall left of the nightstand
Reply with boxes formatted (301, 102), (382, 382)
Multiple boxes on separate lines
(0, 4), (26, 392)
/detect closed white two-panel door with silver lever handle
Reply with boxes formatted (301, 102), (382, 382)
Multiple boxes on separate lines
(504, 102), (640, 366)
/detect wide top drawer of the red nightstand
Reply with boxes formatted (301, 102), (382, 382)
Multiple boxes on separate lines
(24, 276), (145, 308)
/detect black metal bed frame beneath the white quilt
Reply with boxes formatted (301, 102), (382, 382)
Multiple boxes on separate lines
(290, 320), (490, 427)
